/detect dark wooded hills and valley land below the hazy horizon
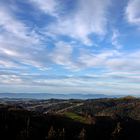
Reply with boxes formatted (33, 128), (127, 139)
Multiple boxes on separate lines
(0, 97), (140, 140)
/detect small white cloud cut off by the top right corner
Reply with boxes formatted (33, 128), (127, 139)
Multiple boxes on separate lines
(125, 0), (140, 25)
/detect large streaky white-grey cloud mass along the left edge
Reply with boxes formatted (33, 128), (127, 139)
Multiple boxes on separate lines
(0, 3), (49, 70)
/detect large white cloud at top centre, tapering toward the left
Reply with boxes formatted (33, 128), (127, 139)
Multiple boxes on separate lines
(49, 0), (110, 45)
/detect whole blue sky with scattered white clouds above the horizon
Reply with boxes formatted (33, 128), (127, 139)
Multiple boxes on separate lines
(0, 0), (140, 95)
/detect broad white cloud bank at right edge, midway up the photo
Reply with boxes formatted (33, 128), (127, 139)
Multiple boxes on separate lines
(76, 50), (140, 72)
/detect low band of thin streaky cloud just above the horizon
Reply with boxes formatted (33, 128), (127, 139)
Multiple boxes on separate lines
(0, 73), (140, 94)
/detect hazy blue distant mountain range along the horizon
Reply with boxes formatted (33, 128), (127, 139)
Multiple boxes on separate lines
(0, 93), (122, 99)
